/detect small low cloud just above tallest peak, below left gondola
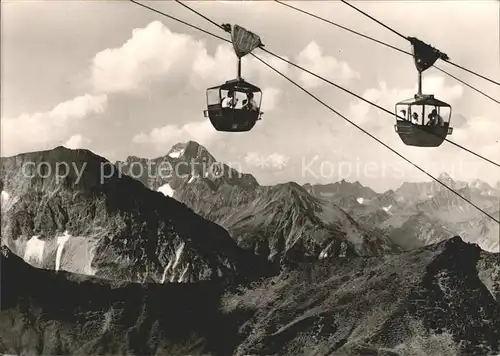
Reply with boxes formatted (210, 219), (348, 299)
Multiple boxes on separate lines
(132, 120), (217, 151)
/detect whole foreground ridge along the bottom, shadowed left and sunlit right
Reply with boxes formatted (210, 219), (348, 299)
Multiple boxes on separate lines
(0, 237), (500, 356)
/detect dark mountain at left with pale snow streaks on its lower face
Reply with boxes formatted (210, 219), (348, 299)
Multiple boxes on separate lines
(0, 147), (268, 282)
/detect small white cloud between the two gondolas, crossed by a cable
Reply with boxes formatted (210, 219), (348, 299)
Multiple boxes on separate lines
(297, 41), (360, 89)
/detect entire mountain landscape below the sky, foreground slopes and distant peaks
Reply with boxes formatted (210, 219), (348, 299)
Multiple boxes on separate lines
(0, 141), (500, 356)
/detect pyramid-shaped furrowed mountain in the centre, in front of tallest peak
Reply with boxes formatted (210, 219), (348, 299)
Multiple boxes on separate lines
(225, 183), (393, 261)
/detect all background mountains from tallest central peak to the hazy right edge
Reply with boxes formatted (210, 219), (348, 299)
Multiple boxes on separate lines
(118, 141), (500, 254)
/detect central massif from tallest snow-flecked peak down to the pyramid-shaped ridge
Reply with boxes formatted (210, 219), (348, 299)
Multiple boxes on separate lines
(122, 141), (398, 265)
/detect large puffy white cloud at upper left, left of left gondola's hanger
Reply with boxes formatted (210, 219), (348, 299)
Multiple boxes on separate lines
(91, 21), (206, 93)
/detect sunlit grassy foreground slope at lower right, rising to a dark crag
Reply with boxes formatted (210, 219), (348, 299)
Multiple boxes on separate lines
(224, 237), (500, 356)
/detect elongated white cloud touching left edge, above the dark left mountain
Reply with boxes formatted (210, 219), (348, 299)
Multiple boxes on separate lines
(1, 94), (108, 156)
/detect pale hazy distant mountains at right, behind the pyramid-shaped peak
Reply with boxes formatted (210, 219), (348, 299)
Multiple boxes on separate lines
(305, 174), (500, 252)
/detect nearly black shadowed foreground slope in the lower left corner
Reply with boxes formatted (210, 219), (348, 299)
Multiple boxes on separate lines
(0, 248), (237, 355)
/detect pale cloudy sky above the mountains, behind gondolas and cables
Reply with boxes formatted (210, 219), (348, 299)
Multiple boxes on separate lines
(1, 0), (500, 191)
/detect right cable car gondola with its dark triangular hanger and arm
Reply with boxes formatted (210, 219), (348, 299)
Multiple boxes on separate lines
(394, 37), (453, 147)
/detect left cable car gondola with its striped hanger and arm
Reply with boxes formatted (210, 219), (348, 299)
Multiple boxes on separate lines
(203, 25), (263, 132)
